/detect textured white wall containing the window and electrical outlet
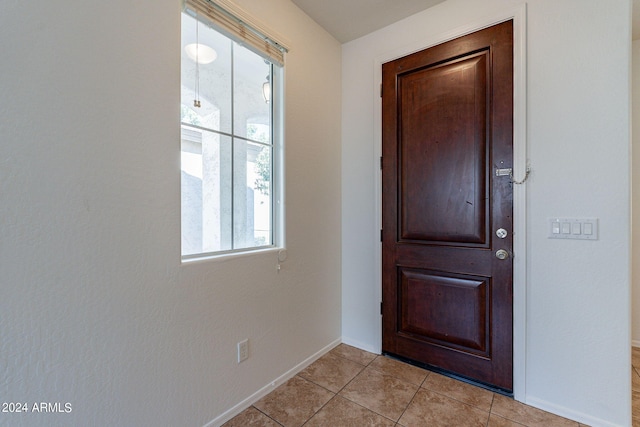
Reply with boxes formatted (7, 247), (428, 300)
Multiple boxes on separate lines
(0, 0), (341, 426)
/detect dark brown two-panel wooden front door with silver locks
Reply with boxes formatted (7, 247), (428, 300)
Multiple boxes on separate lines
(382, 21), (513, 391)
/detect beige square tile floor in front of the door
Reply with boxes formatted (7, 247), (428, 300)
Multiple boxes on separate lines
(224, 344), (592, 427)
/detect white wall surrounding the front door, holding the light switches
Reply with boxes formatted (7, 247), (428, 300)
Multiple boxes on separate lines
(342, 0), (631, 426)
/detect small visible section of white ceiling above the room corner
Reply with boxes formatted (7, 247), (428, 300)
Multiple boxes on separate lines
(291, 0), (444, 43)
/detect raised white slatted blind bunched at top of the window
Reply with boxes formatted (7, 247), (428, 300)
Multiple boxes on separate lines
(184, 0), (288, 66)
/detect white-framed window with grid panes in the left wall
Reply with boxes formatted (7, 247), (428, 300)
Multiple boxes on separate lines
(181, 0), (282, 259)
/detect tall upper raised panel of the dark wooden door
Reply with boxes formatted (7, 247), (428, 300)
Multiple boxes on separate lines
(398, 51), (489, 244)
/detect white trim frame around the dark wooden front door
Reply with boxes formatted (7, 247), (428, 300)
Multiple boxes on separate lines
(372, 3), (527, 402)
